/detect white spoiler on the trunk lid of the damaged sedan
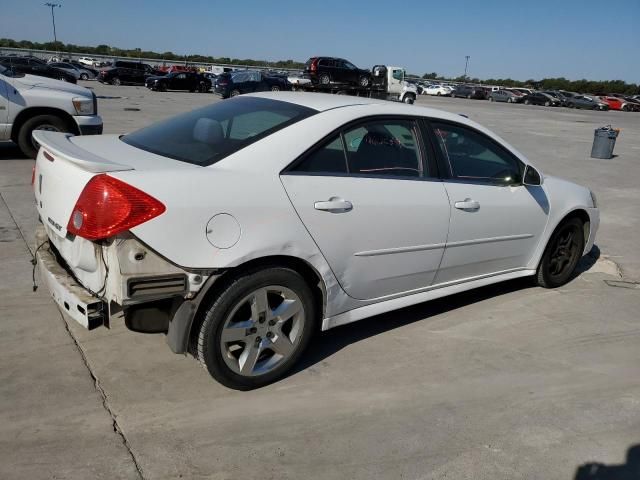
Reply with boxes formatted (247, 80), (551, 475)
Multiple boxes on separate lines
(33, 130), (133, 173)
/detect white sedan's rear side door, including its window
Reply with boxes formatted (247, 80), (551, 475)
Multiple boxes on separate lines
(281, 117), (450, 300)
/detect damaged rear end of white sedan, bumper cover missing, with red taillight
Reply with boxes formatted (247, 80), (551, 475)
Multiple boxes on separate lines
(33, 131), (201, 329)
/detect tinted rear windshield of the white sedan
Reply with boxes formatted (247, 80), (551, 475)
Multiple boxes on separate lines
(122, 97), (317, 166)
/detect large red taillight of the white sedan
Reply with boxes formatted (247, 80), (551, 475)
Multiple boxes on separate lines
(67, 174), (166, 240)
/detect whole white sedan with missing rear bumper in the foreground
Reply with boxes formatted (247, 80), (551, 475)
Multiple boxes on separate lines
(33, 92), (599, 389)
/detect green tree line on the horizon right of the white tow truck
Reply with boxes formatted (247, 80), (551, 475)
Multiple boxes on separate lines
(422, 72), (640, 95)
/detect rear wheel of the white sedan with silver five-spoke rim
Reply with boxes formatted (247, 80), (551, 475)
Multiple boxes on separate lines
(197, 267), (317, 390)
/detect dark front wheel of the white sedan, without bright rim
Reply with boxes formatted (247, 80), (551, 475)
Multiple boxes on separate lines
(536, 217), (584, 288)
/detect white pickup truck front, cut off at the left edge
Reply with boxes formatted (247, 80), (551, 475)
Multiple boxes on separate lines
(0, 65), (102, 158)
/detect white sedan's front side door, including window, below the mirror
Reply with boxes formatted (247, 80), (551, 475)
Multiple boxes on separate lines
(431, 121), (549, 283)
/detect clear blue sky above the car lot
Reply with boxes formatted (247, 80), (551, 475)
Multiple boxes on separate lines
(0, 0), (640, 83)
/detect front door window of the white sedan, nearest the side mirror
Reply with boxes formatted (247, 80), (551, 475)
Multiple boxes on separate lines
(433, 123), (524, 184)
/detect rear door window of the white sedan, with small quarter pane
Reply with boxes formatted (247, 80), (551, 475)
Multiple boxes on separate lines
(293, 120), (423, 178)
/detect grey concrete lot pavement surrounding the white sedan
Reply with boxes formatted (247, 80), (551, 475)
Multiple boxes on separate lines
(0, 82), (640, 480)
